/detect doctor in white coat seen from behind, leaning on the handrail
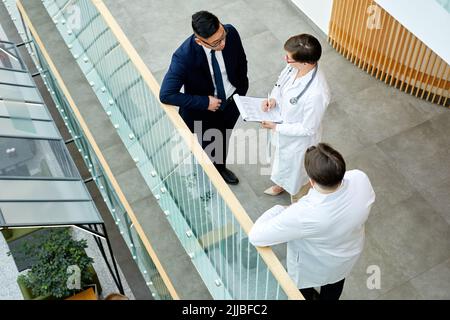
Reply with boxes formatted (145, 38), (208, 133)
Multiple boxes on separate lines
(249, 143), (375, 300)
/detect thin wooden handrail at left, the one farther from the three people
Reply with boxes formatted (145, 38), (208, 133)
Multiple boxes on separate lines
(17, 0), (180, 300)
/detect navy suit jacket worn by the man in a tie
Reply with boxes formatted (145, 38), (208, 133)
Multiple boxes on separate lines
(159, 25), (248, 130)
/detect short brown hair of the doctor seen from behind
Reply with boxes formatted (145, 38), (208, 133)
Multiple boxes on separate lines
(305, 143), (345, 188)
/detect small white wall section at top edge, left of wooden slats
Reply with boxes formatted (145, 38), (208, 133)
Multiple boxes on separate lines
(291, 0), (333, 35)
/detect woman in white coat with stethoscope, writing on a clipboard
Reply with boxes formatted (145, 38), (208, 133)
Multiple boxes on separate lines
(262, 34), (330, 202)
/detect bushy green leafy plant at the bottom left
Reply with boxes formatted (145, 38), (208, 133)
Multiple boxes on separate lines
(13, 228), (93, 298)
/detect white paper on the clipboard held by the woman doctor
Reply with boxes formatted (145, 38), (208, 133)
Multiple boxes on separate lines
(233, 94), (283, 123)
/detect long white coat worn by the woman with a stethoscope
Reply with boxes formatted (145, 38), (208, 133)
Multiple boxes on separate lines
(270, 66), (330, 195)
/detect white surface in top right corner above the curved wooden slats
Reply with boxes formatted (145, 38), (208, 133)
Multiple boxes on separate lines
(375, 0), (450, 64)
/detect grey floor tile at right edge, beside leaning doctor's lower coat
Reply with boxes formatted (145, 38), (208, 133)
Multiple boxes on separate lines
(367, 193), (450, 278)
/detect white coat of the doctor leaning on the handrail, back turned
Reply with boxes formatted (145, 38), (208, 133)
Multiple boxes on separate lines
(249, 170), (375, 289)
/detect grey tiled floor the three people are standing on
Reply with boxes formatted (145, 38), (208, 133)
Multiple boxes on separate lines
(105, 0), (450, 299)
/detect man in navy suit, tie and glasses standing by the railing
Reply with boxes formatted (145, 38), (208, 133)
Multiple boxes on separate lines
(160, 11), (248, 184)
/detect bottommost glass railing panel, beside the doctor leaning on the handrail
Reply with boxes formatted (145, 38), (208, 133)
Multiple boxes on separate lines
(147, 151), (287, 299)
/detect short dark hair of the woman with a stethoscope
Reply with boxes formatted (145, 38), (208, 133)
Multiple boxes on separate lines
(284, 33), (322, 64)
